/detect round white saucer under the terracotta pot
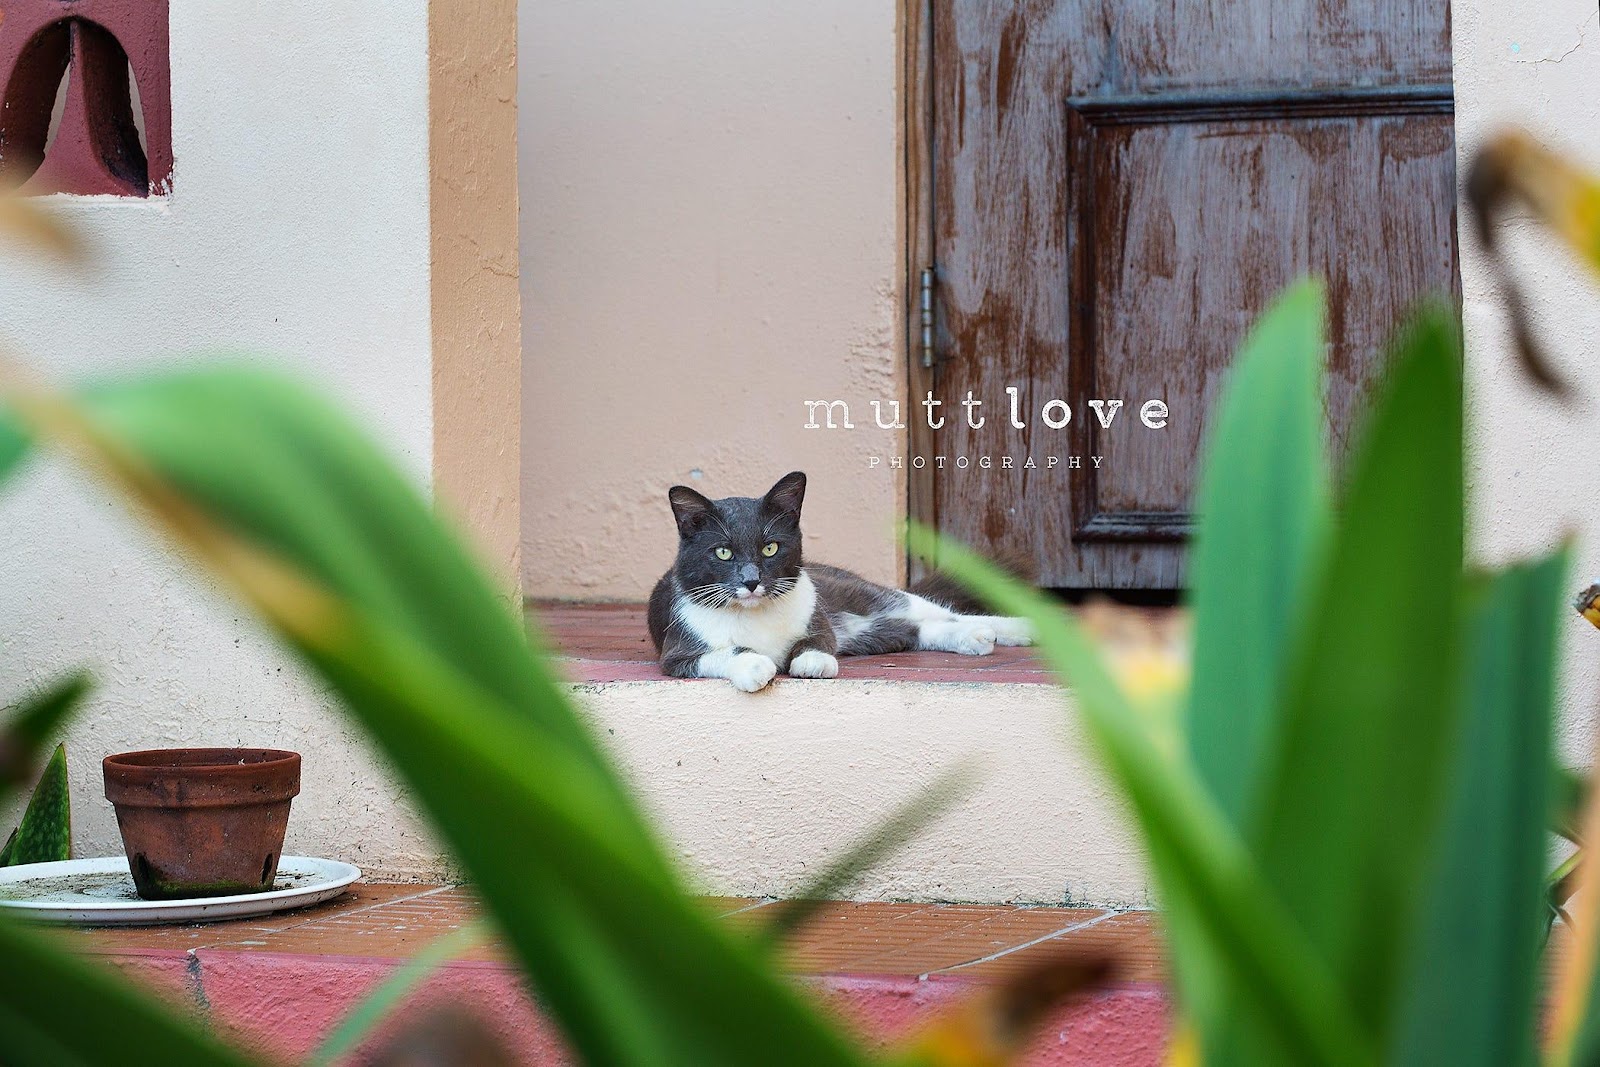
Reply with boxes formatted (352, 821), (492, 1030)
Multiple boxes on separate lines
(0, 856), (362, 926)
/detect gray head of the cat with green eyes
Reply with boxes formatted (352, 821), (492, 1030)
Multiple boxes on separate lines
(667, 470), (805, 608)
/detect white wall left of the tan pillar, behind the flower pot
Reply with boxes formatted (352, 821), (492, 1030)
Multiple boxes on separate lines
(0, 0), (438, 873)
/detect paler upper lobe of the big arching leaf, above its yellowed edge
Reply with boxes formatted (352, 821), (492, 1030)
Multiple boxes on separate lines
(82, 363), (621, 809)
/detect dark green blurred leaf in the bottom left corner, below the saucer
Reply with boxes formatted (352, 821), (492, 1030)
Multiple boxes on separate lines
(0, 917), (258, 1067)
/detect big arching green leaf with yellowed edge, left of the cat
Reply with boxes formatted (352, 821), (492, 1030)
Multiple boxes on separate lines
(3, 366), (861, 1065)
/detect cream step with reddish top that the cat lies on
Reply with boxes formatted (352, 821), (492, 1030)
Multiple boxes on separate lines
(530, 603), (1150, 909)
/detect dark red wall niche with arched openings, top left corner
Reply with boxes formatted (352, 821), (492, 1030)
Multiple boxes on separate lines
(0, 0), (173, 197)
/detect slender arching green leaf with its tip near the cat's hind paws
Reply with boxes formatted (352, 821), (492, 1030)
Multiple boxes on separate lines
(907, 523), (1376, 1067)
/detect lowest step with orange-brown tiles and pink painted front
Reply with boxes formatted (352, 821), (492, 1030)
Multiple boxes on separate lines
(74, 885), (1166, 1067)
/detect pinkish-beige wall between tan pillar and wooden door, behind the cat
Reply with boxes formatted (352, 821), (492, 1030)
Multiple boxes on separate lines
(520, 0), (904, 600)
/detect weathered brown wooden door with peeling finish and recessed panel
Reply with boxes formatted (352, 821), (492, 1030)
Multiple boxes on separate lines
(909, 0), (1459, 590)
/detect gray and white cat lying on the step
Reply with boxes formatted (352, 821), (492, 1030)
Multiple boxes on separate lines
(650, 470), (1034, 693)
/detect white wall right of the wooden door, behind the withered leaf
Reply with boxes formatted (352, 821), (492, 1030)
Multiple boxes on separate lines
(1453, 0), (1600, 763)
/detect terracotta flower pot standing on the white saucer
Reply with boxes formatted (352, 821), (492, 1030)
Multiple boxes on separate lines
(101, 749), (299, 901)
